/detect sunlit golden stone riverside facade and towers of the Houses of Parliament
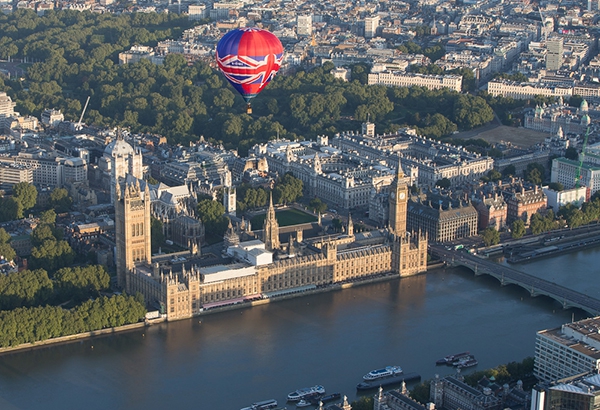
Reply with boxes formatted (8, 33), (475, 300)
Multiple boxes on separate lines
(117, 167), (427, 320)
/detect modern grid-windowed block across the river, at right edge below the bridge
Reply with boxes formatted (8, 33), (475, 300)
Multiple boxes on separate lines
(532, 317), (600, 382)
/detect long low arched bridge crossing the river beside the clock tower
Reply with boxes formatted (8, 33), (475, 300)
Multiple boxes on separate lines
(429, 245), (600, 316)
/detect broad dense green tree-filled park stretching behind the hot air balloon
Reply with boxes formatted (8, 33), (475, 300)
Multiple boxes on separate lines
(0, 9), (512, 155)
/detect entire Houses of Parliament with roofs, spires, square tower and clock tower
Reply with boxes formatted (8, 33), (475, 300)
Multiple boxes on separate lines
(114, 141), (427, 320)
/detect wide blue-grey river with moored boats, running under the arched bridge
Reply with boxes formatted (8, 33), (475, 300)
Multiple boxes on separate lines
(0, 248), (600, 410)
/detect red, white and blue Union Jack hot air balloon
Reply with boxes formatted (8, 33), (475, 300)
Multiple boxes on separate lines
(217, 27), (283, 114)
